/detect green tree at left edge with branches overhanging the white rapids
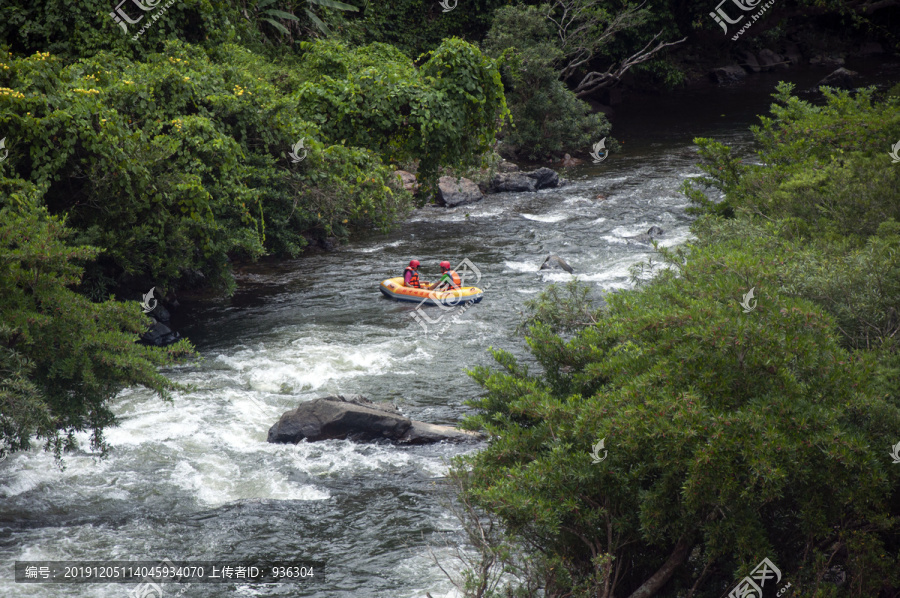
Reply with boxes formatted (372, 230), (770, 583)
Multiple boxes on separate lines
(0, 183), (193, 456)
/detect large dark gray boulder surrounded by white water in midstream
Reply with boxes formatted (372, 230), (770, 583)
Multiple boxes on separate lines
(267, 395), (480, 444)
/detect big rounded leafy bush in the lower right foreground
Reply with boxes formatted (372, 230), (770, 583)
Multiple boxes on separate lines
(454, 244), (900, 598)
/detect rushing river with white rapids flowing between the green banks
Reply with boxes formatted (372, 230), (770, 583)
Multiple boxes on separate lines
(0, 61), (896, 598)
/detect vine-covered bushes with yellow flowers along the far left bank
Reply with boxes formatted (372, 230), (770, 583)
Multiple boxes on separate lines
(0, 40), (505, 289)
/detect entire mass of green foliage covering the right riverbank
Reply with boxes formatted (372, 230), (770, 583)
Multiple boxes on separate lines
(453, 87), (900, 598)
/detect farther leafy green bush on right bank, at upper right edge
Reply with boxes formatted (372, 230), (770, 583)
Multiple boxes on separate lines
(686, 83), (900, 239)
